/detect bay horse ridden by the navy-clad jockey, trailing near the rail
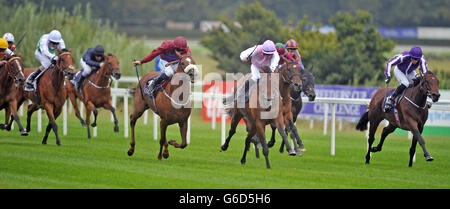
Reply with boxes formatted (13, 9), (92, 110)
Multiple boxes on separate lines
(66, 53), (121, 138)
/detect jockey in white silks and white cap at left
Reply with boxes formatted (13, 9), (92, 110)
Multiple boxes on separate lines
(25, 30), (66, 89)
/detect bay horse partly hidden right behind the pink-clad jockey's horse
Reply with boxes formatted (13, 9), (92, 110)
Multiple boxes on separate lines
(221, 62), (303, 158)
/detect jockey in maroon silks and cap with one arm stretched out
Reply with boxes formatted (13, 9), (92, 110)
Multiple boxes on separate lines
(133, 36), (191, 89)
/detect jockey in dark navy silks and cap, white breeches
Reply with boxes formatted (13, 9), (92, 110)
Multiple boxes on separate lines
(74, 45), (105, 91)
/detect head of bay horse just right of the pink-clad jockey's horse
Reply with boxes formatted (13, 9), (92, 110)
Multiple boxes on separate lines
(280, 62), (303, 91)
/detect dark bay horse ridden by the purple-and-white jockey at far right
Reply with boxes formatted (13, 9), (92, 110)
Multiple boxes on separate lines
(356, 71), (440, 167)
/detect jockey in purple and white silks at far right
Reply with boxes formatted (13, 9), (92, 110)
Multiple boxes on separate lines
(384, 46), (428, 111)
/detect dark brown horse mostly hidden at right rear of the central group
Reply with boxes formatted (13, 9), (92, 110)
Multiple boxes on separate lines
(267, 66), (316, 153)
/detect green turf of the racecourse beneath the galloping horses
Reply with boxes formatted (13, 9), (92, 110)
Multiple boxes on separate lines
(0, 105), (450, 189)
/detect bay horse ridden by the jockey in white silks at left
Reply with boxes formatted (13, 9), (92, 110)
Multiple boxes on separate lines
(24, 49), (75, 146)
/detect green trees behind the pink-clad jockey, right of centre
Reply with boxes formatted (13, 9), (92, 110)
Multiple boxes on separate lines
(201, 2), (394, 85)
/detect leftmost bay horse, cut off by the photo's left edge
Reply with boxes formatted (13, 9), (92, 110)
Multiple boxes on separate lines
(0, 55), (28, 136)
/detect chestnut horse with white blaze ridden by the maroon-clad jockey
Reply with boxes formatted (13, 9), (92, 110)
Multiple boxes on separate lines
(128, 53), (198, 160)
